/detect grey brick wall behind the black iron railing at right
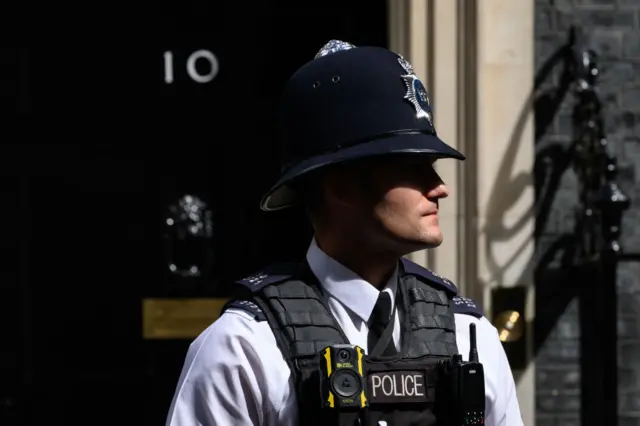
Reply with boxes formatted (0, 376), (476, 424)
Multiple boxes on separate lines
(535, 0), (640, 426)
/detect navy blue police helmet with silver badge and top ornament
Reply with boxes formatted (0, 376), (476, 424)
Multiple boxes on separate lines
(261, 40), (464, 211)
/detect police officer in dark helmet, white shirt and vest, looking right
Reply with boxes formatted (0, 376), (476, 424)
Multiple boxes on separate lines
(167, 40), (522, 426)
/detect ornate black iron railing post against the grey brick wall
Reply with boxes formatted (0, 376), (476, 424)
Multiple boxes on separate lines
(571, 27), (640, 426)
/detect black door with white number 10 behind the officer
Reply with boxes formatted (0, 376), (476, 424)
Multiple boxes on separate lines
(0, 0), (387, 426)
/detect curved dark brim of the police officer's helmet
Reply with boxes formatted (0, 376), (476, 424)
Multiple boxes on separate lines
(260, 133), (465, 211)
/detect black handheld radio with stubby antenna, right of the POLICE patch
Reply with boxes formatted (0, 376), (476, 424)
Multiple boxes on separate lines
(441, 323), (485, 426)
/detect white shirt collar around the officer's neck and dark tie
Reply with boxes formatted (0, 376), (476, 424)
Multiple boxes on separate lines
(307, 238), (398, 321)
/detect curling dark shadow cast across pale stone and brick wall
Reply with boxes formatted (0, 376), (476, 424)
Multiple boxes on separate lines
(482, 27), (592, 370)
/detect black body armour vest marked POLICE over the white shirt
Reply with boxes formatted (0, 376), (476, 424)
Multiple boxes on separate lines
(223, 259), (482, 426)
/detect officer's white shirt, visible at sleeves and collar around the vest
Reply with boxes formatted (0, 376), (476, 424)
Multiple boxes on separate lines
(166, 241), (523, 426)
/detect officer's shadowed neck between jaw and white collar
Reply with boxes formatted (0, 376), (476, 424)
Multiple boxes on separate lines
(315, 228), (399, 289)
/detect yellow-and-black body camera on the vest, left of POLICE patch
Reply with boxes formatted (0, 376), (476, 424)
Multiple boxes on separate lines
(320, 345), (369, 410)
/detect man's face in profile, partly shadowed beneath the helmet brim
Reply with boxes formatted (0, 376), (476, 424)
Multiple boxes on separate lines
(344, 156), (449, 253)
